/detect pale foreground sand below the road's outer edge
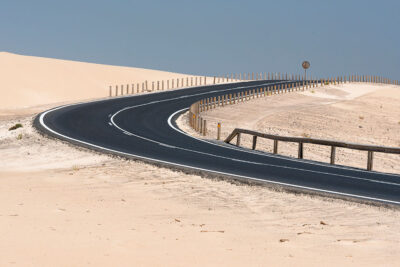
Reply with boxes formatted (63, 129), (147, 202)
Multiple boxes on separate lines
(0, 53), (400, 266)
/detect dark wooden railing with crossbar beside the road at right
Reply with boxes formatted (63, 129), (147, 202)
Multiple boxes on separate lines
(224, 128), (400, 171)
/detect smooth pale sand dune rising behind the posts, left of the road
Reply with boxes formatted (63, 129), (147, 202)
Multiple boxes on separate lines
(0, 51), (192, 110)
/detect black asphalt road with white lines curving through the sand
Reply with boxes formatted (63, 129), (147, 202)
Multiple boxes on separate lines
(35, 81), (400, 206)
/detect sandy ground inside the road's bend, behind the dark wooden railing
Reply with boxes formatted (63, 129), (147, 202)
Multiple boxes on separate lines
(179, 84), (400, 176)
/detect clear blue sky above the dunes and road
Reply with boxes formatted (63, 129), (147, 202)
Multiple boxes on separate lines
(0, 0), (400, 79)
